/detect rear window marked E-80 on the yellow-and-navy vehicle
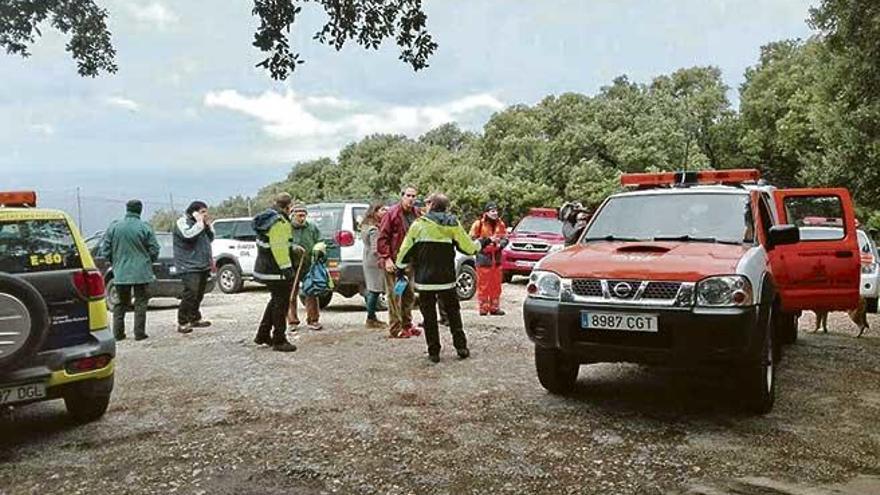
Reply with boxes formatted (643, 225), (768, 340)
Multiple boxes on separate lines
(0, 219), (82, 273)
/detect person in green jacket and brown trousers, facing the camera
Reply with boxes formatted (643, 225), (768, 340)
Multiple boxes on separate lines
(287, 205), (324, 330)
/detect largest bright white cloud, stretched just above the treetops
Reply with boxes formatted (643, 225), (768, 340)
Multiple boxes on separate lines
(204, 90), (504, 143)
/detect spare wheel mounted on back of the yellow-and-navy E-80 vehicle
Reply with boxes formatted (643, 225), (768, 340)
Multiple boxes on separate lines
(0, 273), (50, 373)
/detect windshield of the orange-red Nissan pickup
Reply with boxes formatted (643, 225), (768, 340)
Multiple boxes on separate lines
(584, 193), (753, 243)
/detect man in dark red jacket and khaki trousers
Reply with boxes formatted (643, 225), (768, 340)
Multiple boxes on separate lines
(376, 186), (422, 339)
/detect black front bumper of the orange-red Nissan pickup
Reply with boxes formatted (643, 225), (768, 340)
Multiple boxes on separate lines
(523, 298), (764, 367)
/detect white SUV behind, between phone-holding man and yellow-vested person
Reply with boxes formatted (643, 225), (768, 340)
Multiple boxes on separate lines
(211, 217), (257, 294)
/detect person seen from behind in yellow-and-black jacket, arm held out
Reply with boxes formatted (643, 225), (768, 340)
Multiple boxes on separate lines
(396, 193), (488, 363)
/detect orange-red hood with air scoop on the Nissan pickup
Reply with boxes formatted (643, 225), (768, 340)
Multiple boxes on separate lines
(540, 241), (751, 282)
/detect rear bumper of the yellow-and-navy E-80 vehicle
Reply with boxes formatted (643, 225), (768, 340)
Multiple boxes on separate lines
(0, 329), (116, 400)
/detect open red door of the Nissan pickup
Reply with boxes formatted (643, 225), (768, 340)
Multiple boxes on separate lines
(768, 188), (861, 312)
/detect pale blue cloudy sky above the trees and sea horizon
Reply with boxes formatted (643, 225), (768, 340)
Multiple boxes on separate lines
(0, 0), (813, 232)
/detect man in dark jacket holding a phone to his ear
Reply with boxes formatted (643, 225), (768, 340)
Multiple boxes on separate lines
(174, 201), (214, 333)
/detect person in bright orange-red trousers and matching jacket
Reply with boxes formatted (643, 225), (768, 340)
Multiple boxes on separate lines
(471, 202), (507, 316)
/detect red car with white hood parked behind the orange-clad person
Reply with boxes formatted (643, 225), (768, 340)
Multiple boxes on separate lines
(501, 208), (565, 282)
